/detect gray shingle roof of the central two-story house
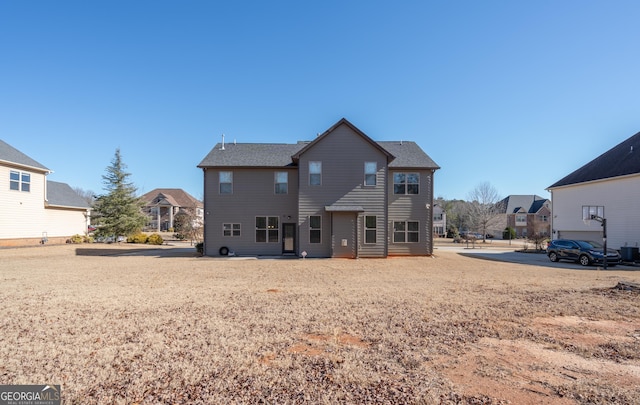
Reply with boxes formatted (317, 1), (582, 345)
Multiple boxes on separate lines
(198, 118), (440, 170)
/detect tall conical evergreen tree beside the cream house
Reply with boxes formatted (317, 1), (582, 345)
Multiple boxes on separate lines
(94, 148), (147, 237)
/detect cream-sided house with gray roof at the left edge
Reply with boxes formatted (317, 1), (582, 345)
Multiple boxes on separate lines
(0, 140), (90, 246)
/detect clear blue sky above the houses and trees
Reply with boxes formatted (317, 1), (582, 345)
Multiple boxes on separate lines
(0, 0), (640, 199)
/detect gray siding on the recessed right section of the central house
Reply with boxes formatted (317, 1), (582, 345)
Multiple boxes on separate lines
(387, 168), (433, 255)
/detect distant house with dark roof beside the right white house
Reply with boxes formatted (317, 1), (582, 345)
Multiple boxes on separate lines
(498, 195), (551, 238)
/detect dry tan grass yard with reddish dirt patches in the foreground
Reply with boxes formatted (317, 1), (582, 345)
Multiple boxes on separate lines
(0, 244), (640, 404)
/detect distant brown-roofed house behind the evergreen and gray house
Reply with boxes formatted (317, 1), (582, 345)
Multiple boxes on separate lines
(140, 188), (204, 232)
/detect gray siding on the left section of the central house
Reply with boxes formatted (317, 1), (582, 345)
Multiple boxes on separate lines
(204, 167), (298, 256)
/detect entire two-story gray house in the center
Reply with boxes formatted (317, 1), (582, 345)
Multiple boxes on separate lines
(198, 119), (439, 258)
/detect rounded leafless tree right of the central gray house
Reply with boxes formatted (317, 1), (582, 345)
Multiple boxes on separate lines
(467, 182), (502, 241)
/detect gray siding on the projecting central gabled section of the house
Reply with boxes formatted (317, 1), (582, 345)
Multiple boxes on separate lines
(298, 125), (387, 257)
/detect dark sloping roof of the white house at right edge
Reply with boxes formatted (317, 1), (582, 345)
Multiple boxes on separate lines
(547, 132), (640, 189)
